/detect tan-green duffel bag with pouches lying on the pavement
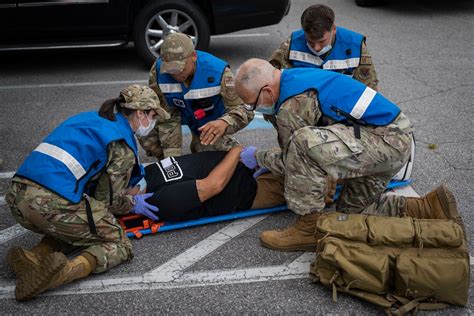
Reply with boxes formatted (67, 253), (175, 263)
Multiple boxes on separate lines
(310, 212), (470, 314)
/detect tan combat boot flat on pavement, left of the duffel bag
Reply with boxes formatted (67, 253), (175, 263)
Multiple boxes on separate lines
(260, 212), (320, 251)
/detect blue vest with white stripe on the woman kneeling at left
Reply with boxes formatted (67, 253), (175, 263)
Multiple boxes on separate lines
(16, 112), (144, 203)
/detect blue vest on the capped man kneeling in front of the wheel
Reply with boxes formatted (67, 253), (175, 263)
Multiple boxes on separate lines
(156, 51), (229, 135)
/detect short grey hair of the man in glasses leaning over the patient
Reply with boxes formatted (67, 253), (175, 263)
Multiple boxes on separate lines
(235, 58), (275, 94)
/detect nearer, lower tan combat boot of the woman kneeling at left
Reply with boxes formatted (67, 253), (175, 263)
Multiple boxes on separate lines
(15, 252), (95, 301)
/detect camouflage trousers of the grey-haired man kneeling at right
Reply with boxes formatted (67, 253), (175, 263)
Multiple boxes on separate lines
(284, 124), (411, 215)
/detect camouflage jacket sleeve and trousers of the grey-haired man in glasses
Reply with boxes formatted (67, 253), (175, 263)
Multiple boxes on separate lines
(256, 91), (412, 215)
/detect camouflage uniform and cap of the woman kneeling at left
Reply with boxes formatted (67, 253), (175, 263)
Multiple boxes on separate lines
(5, 85), (168, 273)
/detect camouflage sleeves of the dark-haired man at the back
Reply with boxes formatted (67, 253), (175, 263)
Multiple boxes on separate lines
(269, 37), (379, 91)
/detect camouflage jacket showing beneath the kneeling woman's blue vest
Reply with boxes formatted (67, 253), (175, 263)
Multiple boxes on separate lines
(12, 141), (135, 215)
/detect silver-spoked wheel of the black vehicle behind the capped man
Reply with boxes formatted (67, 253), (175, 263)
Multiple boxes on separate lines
(133, 0), (211, 66)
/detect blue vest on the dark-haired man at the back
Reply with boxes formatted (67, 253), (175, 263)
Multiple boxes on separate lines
(289, 26), (365, 75)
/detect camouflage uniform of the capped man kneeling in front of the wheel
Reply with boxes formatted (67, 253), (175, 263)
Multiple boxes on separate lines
(139, 58), (254, 159)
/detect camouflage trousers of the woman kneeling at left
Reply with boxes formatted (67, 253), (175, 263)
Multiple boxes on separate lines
(6, 181), (133, 273)
